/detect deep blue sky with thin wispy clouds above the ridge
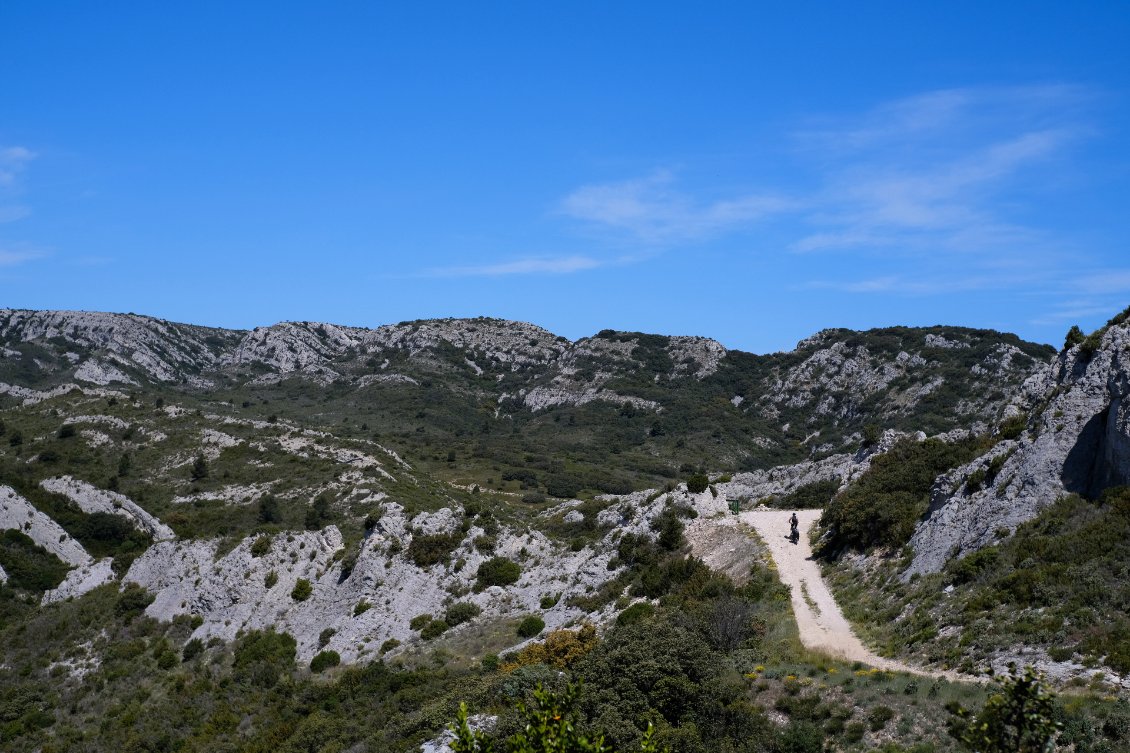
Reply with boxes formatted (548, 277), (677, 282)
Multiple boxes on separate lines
(0, 0), (1130, 352)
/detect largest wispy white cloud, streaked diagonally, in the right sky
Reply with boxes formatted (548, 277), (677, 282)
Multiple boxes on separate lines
(791, 85), (1090, 256)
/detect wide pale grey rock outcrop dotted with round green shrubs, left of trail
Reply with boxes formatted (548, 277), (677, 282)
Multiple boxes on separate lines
(124, 502), (637, 663)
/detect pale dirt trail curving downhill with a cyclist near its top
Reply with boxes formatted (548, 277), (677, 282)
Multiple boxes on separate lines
(741, 510), (971, 681)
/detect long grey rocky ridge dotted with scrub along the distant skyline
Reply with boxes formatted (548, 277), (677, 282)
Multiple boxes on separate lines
(0, 310), (1053, 454)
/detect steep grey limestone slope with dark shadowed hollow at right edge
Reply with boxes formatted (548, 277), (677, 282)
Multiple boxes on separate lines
(904, 314), (1130, 577)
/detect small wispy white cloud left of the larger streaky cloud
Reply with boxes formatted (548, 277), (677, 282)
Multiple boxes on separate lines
(559, 170), (798, 243)
